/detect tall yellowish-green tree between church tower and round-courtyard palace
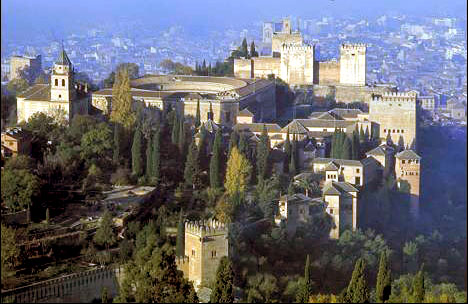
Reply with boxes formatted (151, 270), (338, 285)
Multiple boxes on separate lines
(110, 68), (136, 131)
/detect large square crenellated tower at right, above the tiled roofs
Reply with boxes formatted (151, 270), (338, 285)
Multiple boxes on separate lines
(369, 92), (417, 150)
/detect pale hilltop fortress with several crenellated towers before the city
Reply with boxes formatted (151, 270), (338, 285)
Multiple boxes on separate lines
(234, 18), (396, 102)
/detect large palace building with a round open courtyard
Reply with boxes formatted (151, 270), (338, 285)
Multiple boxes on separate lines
(91, 75), (276, 126)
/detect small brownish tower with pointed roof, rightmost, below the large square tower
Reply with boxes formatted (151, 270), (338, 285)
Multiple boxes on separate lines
(395, 150), (421, 217)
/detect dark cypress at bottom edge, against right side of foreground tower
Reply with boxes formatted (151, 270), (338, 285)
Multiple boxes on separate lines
(210, 257), (234, 303)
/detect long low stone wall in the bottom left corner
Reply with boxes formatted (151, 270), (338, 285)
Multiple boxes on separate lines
(2, 267), (122, 303)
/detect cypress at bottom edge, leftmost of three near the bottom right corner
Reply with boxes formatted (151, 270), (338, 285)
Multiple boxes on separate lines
(345, 258), (369, 303)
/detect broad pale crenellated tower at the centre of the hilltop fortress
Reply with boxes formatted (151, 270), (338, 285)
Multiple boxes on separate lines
(280, 43), (314, 85)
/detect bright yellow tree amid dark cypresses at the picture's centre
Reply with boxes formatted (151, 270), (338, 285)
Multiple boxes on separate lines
(225, 147), (252, 197)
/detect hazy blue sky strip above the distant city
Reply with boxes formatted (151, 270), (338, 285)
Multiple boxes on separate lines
(1, 0), (466, 42)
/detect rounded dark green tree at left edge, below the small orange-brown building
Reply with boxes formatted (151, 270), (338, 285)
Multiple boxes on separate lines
(1, 169), (40, 211)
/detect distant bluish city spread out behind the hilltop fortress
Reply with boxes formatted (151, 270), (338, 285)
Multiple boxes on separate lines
(2, 15), (467, 105)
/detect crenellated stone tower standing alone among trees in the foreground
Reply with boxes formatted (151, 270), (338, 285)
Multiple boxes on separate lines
(177, 219), (229, 288)
